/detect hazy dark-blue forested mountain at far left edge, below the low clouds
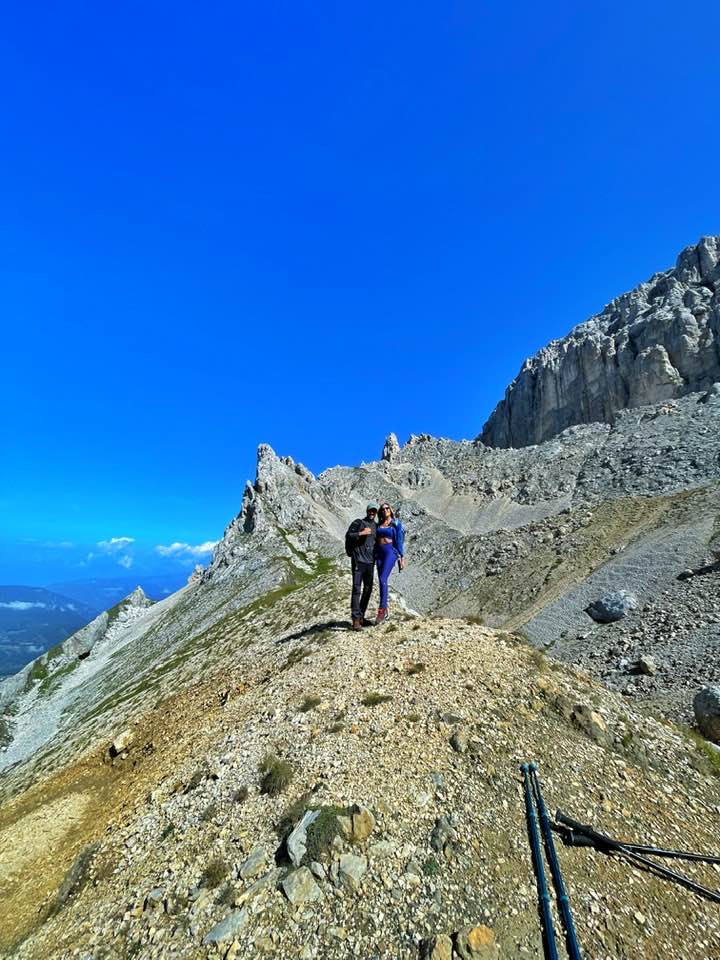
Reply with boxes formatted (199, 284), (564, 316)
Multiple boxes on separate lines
(0, 586), (98, 676)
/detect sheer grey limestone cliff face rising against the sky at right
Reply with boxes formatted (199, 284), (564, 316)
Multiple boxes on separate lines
(479, 237), (720, 447)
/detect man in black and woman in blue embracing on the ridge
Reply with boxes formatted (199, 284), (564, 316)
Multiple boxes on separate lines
(345, 502), (405, 630)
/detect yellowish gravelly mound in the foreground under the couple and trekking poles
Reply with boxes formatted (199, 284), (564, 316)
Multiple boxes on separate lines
(0, 584), (720, 960)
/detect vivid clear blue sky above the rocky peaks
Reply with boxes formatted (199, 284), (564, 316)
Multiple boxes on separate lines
(0, 0), (720, 582)
